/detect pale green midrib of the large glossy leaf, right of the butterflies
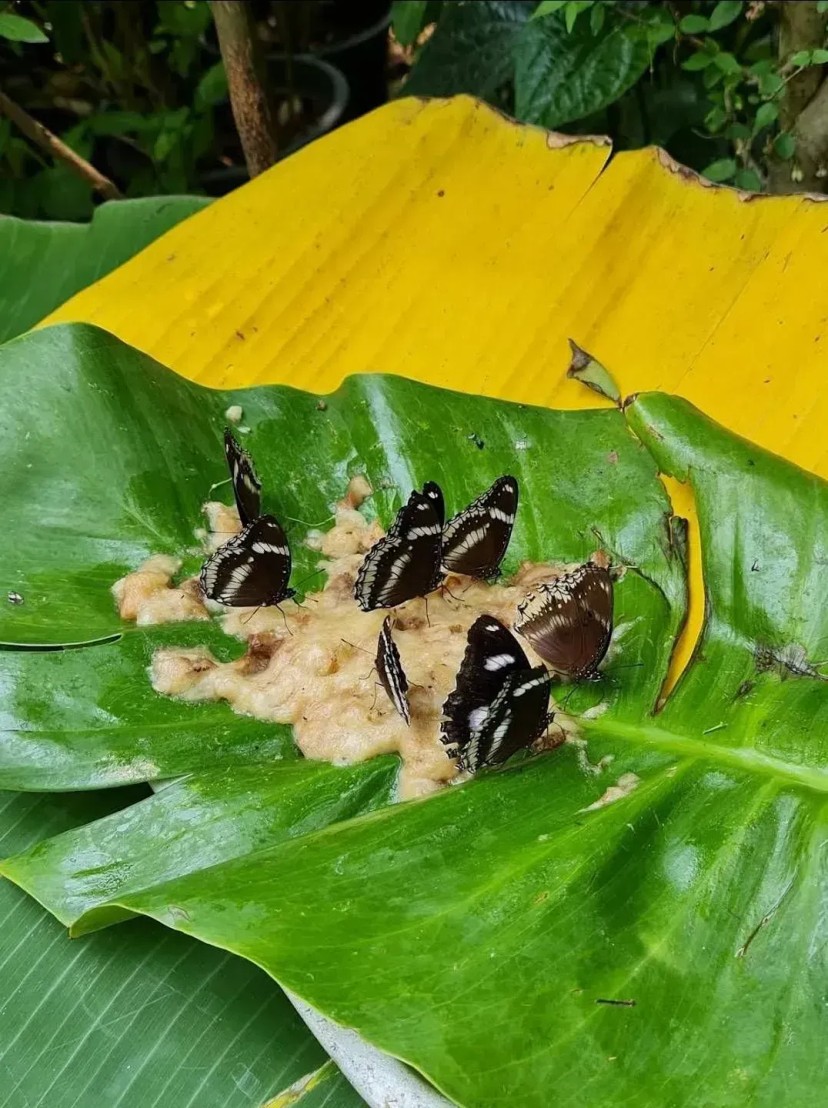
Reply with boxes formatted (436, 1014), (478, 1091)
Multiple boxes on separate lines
(582, 719), (828, 792)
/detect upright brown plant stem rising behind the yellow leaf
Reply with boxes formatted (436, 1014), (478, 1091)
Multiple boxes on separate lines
(211, 0), (278, 177)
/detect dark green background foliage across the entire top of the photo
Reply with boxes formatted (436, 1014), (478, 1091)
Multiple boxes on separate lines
(0, 0), (828, 219)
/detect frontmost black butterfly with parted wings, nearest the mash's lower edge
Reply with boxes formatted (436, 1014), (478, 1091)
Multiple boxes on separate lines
(440, 615), (552, 772)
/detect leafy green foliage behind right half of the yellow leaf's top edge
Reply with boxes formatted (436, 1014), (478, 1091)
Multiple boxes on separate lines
(393, 0), (828, 191)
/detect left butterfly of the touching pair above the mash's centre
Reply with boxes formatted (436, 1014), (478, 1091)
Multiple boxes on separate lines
(354, 482), (442, 612)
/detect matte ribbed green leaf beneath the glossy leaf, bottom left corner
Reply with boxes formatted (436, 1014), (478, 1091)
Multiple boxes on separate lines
(0, 790), (343, 1108)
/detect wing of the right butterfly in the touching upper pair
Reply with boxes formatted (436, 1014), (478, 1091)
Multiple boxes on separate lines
(442, 476), (518, 578)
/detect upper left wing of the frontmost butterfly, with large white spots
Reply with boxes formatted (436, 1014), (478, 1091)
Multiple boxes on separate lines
(440, 615), (529, 750)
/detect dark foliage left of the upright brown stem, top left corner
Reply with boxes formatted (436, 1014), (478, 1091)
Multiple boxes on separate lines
(0, 0), (227, 219)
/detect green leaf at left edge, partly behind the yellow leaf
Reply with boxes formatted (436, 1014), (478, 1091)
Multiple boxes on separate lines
(0, 196), (209, 342)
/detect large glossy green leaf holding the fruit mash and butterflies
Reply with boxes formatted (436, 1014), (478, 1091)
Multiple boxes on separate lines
(0, 327), (828, 1108)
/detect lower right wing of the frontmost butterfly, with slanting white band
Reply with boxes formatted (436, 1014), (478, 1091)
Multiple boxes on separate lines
(460, 666), (551, 773)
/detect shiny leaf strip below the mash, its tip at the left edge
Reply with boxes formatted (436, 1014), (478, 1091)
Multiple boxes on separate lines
(0, 758), (397, 936)
